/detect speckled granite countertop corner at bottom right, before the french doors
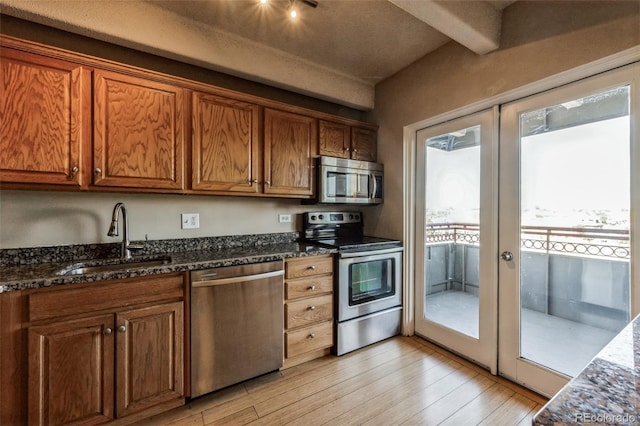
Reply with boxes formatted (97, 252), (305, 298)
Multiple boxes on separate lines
(533, 316), (640, 425)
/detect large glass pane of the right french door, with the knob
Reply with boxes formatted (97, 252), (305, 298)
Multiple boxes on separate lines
(520, 87), (630, 376)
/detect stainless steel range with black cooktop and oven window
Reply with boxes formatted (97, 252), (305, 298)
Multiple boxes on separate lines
(303, 211), (403, 355)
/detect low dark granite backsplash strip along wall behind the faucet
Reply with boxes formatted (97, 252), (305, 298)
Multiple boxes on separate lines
(0, 232), (299, 266)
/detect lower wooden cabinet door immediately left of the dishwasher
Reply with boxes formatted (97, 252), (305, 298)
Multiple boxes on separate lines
(116, 302), (184, 417)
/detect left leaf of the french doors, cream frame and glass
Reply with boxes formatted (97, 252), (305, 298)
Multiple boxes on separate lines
(415, 108), (498, 373)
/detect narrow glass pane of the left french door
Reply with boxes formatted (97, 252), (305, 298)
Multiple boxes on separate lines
(424, 125), (480, 338)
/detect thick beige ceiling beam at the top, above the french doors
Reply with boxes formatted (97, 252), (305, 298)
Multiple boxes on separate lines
(389, 0), (502, 55)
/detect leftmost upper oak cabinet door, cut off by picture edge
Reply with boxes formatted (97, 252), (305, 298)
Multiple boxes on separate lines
(0, 48), (91, 187)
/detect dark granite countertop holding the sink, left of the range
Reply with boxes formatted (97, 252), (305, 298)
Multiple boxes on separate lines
(0, 233), (336, 293)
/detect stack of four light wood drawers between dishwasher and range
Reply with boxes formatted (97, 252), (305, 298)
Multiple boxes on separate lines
(284, 255), (334, 368)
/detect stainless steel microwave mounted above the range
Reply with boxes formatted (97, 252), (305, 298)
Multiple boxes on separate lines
(316, 157), (384, 205)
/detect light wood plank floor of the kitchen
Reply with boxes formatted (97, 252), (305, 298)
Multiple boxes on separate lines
(138, 337), (546, 426)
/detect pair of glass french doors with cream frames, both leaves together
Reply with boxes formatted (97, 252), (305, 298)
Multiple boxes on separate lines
(415, 65), (640, 395)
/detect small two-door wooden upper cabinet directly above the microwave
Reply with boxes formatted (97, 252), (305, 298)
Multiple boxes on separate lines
(319, 120), (378, 161)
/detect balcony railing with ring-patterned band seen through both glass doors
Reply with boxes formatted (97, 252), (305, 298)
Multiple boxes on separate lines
(425, 223), (630, 259)
